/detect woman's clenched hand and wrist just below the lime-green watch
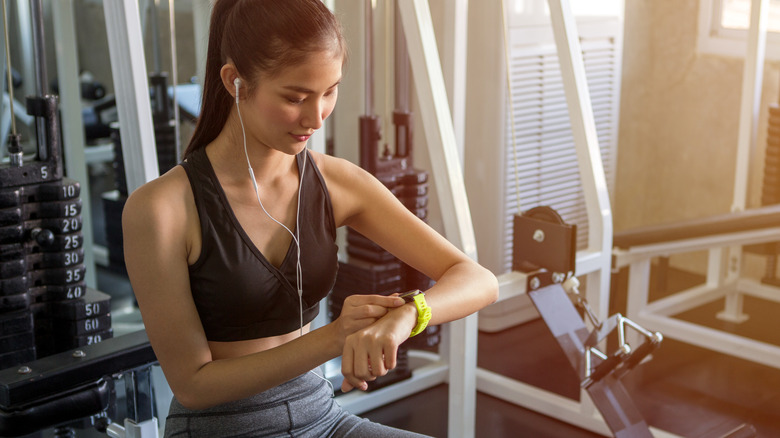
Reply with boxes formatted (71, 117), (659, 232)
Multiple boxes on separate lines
(341, 298), (417, 392)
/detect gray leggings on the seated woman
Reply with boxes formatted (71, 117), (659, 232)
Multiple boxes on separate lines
(165, 372), (424, 438)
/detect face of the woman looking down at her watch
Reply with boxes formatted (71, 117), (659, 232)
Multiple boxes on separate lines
(241, 52), (342, 154)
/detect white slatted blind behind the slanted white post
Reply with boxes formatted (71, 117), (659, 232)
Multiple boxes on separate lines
(503, 36), (620, 271)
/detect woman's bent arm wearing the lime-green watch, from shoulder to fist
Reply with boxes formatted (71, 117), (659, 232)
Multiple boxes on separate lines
(318, 153), (498, 389)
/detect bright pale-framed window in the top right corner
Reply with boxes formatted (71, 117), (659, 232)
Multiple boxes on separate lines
(699, 0), (780, 60)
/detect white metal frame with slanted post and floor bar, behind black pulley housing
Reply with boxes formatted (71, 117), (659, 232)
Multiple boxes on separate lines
(470, 0), (684, 436)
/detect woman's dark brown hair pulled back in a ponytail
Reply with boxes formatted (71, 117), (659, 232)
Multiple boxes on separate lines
(184, 0), (346, 157)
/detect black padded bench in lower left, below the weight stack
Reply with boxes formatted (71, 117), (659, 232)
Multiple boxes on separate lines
(0, 330), (157, 437)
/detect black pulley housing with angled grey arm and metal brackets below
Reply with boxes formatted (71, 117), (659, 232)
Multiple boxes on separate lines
(512, 206), (663, 438)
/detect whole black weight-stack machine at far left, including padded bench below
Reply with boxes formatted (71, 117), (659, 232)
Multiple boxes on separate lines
(0, 1), (157, 437)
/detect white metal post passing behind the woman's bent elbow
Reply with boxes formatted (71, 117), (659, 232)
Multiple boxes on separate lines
(398, 0), (477, 437)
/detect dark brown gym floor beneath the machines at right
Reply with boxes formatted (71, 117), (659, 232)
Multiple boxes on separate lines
(365, 266), (780, 438)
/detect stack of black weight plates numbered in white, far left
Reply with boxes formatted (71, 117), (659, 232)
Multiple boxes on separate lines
(0, 178), (110, 368)
